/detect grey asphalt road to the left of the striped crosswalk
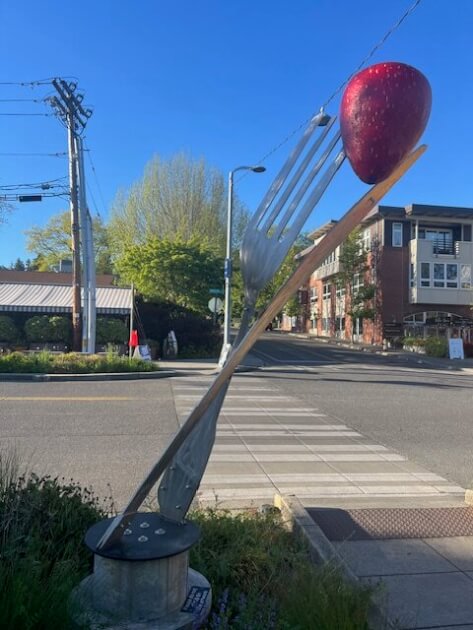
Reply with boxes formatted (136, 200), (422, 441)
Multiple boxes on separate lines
(0, 379), (178, 507)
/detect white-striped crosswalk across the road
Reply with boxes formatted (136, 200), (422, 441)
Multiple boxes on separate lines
(170, 376), (464, 506)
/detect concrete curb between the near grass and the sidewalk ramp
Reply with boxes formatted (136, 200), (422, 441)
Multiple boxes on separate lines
(274, 492), (390, 630)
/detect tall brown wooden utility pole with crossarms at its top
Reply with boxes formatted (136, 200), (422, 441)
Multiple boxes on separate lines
(48, 79), (92, 352)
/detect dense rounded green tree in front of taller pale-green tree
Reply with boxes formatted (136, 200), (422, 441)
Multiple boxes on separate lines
(116, 237), (223, 314)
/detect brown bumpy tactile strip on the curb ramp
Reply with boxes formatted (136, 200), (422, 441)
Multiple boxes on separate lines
(307, 507), (473, 541)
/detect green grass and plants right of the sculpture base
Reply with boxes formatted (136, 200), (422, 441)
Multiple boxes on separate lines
(190, 510), (372, 630)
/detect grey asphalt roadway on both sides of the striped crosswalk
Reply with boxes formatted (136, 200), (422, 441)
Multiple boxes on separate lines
(0, 333), (473, 507)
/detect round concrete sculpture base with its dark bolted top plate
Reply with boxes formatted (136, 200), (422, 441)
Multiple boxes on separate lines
(71, 513), (211, 630)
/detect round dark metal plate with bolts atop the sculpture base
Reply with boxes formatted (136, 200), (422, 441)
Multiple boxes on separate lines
(84, 512), (200, 561)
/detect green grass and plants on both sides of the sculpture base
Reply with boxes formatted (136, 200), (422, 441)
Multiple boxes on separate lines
(0, 451), (371, 630)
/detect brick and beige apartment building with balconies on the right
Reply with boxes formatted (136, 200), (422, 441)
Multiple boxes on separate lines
(300, 204), (473, 344)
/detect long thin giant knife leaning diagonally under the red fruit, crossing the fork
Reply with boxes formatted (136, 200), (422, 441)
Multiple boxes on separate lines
(97, 145), (426, 550)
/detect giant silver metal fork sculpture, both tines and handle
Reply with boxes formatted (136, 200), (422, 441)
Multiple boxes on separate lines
(158, 111), (345, 521)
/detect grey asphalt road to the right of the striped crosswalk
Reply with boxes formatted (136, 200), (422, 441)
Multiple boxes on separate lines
(255, 333), (473, 488)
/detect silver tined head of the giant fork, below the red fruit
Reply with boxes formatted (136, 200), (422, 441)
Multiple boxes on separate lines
(240, 110), (345, 305)
